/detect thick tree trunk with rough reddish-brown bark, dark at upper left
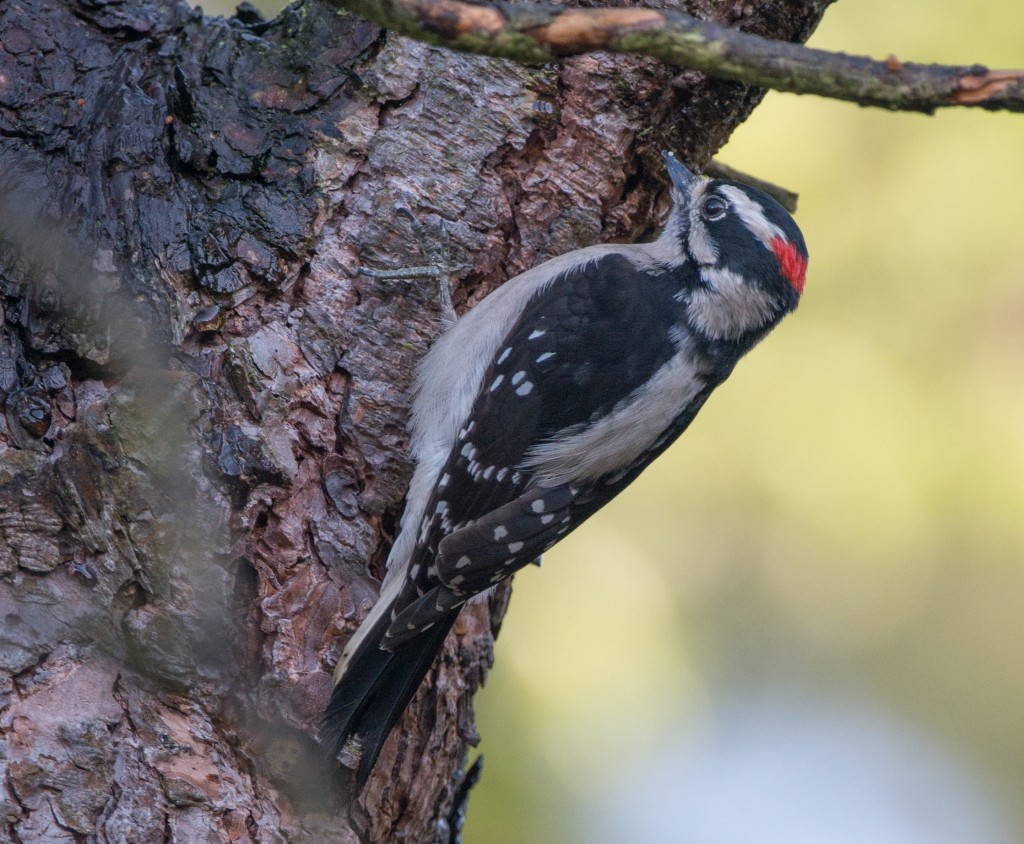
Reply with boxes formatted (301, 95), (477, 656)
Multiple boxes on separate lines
(0, 0), (825, 843)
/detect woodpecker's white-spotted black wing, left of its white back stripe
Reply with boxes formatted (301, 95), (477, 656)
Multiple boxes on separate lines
(387, 254), (695, 645)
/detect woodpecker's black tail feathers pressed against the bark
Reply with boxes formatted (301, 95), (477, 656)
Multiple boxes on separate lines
(321, 610), (459, 789)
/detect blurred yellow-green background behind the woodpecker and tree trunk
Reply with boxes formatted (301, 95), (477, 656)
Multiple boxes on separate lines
(204, 0), (1024, 844)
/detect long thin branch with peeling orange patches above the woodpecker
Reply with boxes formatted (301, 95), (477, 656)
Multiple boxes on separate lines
(332, 0), (1024, 114)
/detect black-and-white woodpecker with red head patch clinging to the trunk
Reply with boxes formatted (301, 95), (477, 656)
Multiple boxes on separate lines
(321, 153), (807, 788)
